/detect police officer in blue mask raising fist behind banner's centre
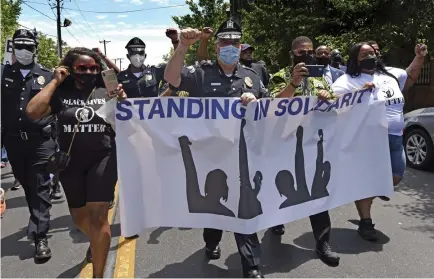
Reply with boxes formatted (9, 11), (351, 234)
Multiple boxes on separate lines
(164, 19), (268, 278)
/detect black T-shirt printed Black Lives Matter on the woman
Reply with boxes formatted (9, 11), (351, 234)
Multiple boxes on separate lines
(50, 88), (115, 156)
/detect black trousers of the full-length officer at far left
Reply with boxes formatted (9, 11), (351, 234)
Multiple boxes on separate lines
(4, 136), (55, 240)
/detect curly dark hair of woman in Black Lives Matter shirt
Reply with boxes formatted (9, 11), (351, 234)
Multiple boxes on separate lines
(59, 47), (105, 87)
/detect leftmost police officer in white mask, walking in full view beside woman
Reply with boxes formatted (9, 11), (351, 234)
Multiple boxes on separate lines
(1, 29), (55, 260)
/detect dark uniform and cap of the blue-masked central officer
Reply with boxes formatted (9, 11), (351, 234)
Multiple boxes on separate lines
(171, 20), (269, 278)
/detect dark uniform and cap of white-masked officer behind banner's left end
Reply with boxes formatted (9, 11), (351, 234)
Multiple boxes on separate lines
(118, 38), (166, 98)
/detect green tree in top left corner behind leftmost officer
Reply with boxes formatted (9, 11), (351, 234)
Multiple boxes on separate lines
(0, 0), (21, 62)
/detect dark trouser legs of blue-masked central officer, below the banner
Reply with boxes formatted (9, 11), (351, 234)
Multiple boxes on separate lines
(203, 229), (261, 272)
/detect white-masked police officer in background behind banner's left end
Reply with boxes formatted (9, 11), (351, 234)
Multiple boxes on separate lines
(118, 37), (166, 98)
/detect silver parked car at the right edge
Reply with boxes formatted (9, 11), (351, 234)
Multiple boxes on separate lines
(404, 107), (434, 169)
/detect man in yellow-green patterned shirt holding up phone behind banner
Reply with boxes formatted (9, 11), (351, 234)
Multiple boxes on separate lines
(269, 36), (340, 267)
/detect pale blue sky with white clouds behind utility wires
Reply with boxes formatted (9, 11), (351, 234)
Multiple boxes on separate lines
(18, 0), (198, 69)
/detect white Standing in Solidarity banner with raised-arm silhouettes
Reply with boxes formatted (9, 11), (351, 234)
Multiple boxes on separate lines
(116, 90), (393, 236)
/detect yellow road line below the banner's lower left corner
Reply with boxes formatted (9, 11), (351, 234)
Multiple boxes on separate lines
(113, 236), (136, 278)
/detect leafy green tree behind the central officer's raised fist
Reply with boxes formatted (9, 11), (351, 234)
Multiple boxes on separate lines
(170, 0), (228, 65)
